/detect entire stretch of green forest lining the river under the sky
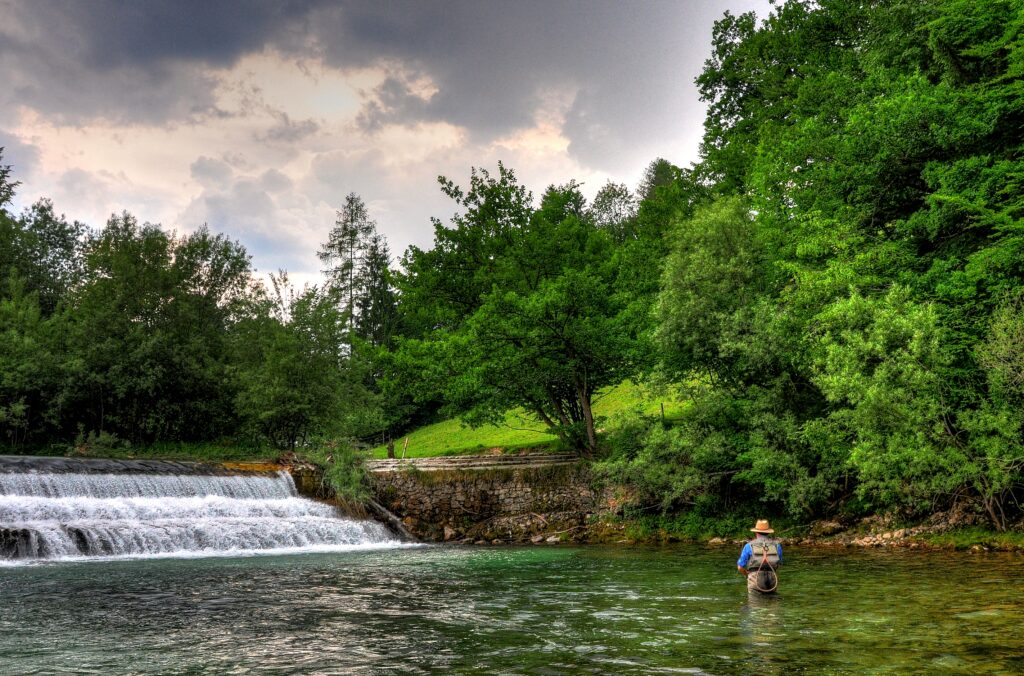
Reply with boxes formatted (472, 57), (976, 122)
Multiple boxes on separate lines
(0, 0), (1024, 530)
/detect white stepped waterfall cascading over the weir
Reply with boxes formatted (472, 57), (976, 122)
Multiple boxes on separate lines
(0, 463), (398, 560)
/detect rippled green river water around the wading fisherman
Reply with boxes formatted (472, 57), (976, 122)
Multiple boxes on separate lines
(0, 546), (1024, 674)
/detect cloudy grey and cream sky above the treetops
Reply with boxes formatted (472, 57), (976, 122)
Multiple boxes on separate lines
(0, 0), (770, 283)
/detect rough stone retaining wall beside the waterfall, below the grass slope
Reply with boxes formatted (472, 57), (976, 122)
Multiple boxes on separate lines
(371, 464), (607, 544)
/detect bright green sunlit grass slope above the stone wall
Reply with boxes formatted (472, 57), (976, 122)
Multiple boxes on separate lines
(371, 381), (684, 458)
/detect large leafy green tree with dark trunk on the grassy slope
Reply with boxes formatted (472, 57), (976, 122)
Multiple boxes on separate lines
(397, 174), (636, 454)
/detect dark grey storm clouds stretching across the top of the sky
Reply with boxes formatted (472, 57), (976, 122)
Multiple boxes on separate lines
(0, 0), (764, 167)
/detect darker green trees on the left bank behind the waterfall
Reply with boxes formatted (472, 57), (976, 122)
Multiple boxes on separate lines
(0, 172), (387, 453)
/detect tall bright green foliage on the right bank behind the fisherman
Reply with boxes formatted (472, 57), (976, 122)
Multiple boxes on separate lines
(607, 0), (1024, 529)
